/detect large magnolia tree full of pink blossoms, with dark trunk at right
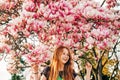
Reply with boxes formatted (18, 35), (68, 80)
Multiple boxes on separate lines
(0, 0), (120, 80)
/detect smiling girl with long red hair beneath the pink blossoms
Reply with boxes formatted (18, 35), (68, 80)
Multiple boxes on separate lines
(40, 46), (90, 80)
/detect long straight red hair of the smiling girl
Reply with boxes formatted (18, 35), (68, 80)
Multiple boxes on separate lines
(48, 46), (74, 80)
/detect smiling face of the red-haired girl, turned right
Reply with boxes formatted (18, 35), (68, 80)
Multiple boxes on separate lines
(60, 48), (69, 64)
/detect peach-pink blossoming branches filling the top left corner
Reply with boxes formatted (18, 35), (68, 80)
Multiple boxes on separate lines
(0, 0), (23, 25)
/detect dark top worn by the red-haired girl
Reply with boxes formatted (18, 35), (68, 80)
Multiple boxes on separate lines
(41, 66), (77, 80)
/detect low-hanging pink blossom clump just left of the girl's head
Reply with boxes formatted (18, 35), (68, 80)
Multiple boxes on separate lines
(26, 45), (49, 64)
